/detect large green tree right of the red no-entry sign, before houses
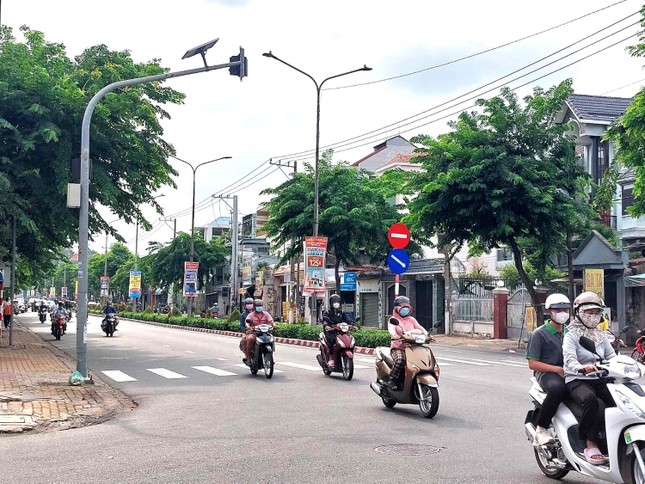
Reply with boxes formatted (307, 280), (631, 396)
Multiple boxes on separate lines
(405, 81), (589, 317)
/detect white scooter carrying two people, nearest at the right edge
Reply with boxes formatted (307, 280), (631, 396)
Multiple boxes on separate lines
(524, 336), (645, 484)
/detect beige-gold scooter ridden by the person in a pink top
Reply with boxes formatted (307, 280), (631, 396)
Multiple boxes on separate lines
(370, 318), (440, 418)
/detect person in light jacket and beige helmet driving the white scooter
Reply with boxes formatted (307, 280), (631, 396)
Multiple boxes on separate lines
(562, 291), (616, 465)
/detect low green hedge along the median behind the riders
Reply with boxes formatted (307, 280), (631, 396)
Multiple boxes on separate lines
(98, 310), (390, 348)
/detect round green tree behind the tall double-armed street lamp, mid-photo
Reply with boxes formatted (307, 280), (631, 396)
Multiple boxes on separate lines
(262, 150), (418, 288)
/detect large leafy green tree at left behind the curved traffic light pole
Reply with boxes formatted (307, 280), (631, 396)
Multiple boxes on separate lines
(0, 26), (184, 284)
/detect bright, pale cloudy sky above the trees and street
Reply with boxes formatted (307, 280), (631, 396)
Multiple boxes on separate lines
(5, 0), (645, 254)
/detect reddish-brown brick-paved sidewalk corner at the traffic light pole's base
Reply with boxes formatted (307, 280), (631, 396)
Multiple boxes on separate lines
(0, 322), (136, 434)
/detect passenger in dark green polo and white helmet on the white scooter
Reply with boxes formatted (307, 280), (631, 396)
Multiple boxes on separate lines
(526, 294), (571, 445)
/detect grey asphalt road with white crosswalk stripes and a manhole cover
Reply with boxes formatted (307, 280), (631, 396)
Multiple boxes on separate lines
(0, 313), (590, 483)
